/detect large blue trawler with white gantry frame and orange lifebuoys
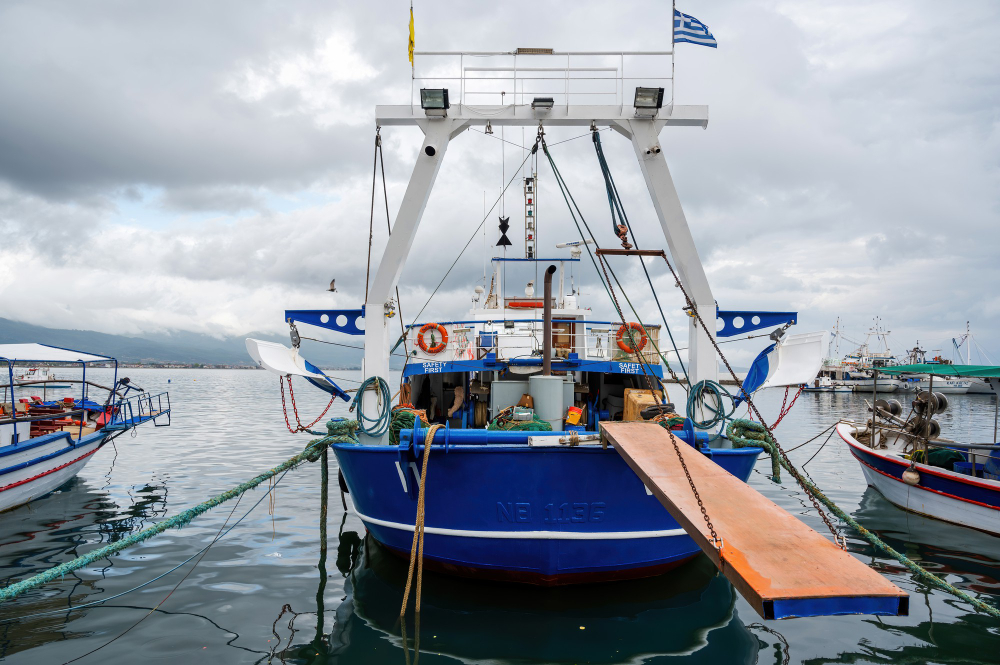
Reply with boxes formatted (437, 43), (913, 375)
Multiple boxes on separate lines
(247, 50), (826, 585)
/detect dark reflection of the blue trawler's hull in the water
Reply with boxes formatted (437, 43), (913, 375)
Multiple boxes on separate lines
(274, 531), (760, 663)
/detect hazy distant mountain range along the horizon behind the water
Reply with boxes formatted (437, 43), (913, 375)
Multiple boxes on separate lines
(0, 318), (363, 369)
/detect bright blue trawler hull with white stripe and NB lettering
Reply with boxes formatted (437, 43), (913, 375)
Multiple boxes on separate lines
(333, 443), (761, 584)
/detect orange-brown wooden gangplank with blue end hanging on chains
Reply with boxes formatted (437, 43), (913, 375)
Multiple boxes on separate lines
(601, 422), (909, 619)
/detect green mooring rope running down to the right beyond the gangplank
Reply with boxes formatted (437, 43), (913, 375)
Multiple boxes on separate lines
(726, 419), (1000, 619)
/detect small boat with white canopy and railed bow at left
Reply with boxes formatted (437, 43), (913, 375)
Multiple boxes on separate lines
(0, 344), (170, 512)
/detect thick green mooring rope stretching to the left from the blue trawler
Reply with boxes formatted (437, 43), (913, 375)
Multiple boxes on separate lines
(0, 418), (358, 602)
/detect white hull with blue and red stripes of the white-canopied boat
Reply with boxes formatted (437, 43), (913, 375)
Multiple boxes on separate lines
(0, 432), (108, 512)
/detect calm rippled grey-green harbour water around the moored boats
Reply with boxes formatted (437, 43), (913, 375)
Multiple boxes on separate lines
(0, 370), (1000, 665)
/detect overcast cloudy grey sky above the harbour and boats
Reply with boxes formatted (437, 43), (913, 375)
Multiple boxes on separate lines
(0, 0), (1000, 364)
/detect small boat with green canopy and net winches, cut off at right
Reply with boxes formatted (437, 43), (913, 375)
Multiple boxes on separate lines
(837, 364), (1000, 535)
